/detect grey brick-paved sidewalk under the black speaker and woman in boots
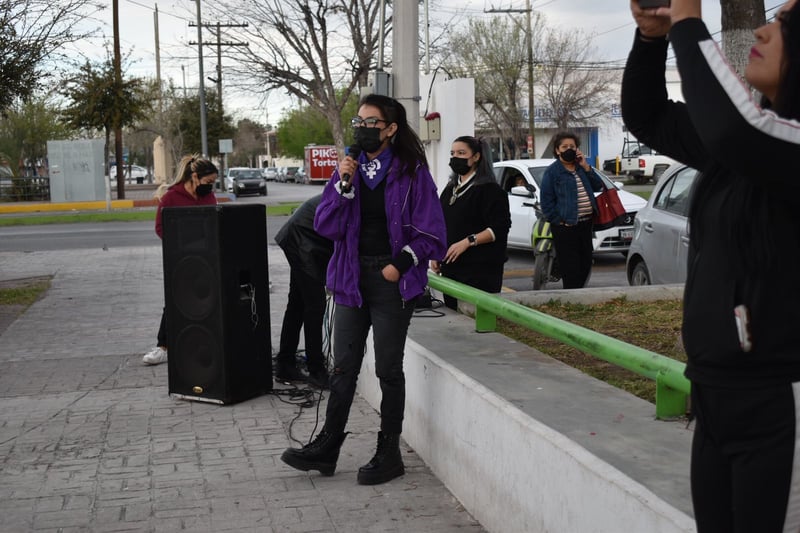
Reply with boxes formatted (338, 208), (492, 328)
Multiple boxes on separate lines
(0, 244), (483, 533)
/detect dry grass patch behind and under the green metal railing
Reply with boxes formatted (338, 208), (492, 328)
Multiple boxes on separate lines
(497, 298), (686, 404)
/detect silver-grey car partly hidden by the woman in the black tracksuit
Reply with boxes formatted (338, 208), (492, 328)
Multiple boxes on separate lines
(626, 164), (698, 285)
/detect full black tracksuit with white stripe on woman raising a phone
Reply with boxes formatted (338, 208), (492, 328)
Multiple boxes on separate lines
(622, 19), (800, 533)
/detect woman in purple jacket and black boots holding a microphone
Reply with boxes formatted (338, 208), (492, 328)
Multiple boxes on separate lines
(281, 94), (447, 485)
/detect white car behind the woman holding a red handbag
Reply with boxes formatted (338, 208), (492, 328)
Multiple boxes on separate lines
(494, 159), (646, 254)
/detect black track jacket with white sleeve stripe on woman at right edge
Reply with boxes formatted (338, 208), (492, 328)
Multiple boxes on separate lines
(622, 19), (800, 388)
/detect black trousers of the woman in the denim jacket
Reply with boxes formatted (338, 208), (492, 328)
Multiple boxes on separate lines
(551, 219), (594, 289)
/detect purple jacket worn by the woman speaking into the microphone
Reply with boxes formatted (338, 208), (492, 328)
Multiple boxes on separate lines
(314, 154), (447, 307)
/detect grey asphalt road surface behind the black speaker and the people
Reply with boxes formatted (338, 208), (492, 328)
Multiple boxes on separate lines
(0, 182), (632, 291)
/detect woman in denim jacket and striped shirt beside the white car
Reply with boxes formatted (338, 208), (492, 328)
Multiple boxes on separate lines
(541, 131), (603, 289)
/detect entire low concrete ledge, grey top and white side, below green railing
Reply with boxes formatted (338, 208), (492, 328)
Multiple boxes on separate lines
(359, 302), (695, 533)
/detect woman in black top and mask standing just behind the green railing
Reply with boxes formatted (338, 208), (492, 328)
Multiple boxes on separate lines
(431, 135), (511, 309)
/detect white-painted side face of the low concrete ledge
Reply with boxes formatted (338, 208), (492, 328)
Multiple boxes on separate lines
(358, 332), (695, 533)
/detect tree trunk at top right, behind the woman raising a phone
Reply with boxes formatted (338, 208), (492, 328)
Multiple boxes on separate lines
(720, 0), (766, 77)
